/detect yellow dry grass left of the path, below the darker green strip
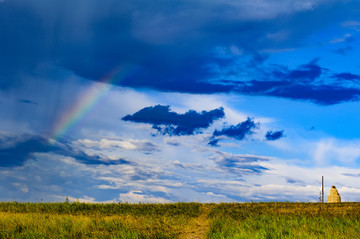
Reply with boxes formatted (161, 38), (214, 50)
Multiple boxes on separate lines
(0, 212), (187, 238)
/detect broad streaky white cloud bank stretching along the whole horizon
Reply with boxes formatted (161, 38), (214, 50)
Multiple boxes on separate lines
(4, 138), (360, 203)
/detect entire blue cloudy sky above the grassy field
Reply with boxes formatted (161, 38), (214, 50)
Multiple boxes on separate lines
(0, 0), (360, 203)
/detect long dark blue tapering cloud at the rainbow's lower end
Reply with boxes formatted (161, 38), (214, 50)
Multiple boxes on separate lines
(0, 135), (130, 167)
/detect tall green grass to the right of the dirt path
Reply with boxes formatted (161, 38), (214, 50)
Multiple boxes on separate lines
(208, 203), (360, 238)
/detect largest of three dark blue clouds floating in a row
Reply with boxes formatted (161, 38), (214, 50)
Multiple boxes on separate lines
(122, 105), (225, 135)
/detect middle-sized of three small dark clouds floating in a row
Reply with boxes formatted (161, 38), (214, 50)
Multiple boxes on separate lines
(209, 118), (258, 146)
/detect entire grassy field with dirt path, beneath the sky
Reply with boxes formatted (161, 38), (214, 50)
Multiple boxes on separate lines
(0, 202), (360, 238)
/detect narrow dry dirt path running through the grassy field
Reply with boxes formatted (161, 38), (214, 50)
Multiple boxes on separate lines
(179, 205), (211, 239)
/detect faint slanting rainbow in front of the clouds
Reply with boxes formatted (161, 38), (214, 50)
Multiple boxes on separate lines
(49, 66), (132, 143)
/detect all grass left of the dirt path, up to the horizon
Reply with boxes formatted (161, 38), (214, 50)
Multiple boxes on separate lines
(0, 203), (200, 238)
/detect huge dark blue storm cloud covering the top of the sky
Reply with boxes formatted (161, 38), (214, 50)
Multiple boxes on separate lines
(0, 0), (360, 105)
